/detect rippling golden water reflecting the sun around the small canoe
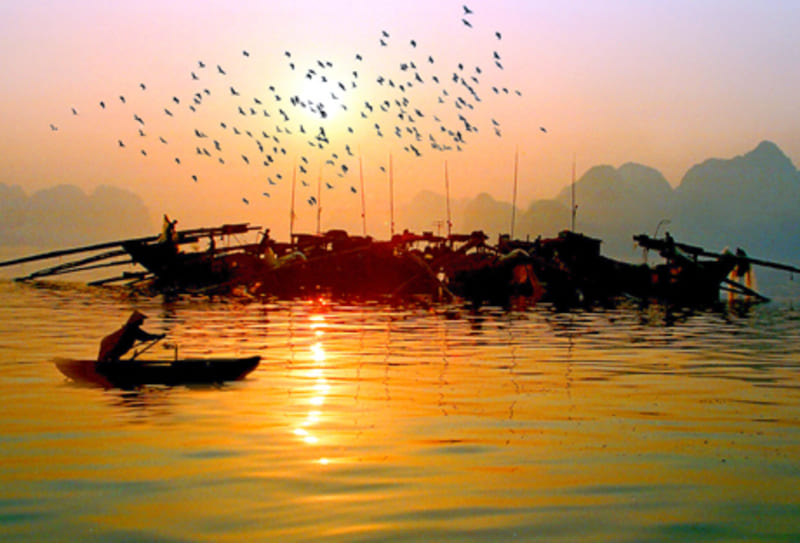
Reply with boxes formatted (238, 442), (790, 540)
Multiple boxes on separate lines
(0, 282), (800, 543)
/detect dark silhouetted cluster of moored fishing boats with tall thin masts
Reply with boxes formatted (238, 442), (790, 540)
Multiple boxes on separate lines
(109, 224), (770, 306)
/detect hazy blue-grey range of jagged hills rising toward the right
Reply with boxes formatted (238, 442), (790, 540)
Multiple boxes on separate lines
(404, 141), (800, 262)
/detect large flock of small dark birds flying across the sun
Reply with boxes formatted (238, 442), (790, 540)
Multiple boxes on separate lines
(50, 6), (546, 210)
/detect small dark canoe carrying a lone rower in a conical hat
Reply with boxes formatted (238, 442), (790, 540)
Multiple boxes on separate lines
(55, 356), (261, 388)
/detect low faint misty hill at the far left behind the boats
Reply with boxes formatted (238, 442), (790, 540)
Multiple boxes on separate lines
(0, 183), (157, 248)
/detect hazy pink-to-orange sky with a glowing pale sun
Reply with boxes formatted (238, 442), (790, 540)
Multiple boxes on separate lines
(0, 0), (800, 237)
